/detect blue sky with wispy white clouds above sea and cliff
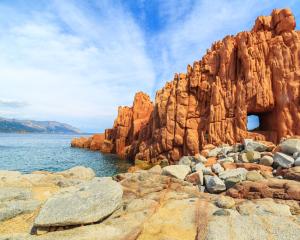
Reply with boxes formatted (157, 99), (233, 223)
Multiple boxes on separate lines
(0, 0), (300, 132)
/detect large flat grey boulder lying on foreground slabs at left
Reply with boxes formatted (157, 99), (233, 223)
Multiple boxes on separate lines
(34, 178), (123, 227)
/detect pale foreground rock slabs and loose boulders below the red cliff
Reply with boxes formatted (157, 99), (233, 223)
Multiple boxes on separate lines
(0, 138), (300, 240)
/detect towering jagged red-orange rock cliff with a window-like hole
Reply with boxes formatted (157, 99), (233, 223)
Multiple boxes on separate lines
(105, 9), (300, 162)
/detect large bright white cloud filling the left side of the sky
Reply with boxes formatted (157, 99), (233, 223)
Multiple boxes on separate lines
(0, 1), (154, 130)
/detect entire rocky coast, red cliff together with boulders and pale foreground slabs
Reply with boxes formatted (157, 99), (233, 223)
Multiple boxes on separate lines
(0, 9), (300, 240)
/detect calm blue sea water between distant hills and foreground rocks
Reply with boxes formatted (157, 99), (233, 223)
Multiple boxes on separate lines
(0, 134), (130, 176)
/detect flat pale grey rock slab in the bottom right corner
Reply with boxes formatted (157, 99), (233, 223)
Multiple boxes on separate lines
(205, 209), (300, 240)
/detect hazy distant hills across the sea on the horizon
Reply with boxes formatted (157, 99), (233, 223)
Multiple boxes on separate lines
(0, 117), (81, 133)
